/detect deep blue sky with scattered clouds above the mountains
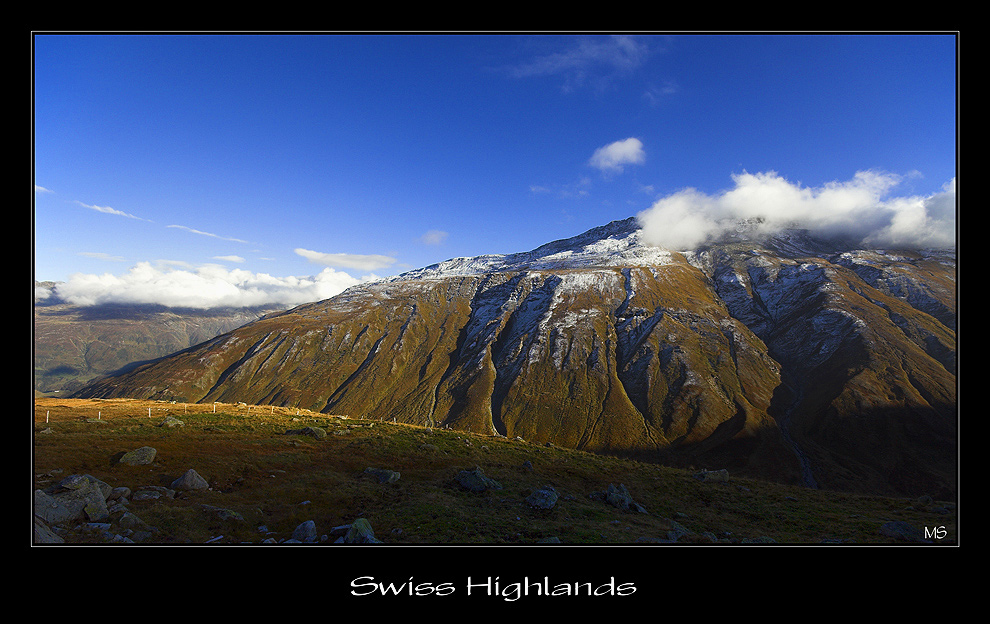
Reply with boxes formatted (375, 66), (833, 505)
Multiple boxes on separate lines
(33, 33), (957, 307)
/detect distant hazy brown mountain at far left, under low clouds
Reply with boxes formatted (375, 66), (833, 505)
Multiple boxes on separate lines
(33, 294), (284, 394)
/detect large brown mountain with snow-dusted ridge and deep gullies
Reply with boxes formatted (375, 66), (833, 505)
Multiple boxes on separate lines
(68, 218), (957, 498)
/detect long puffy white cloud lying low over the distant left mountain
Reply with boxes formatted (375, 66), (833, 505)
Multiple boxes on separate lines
(53, 262), (374, 309)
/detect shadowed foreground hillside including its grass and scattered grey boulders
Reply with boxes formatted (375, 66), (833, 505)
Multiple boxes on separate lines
(32, 402), (955, 545)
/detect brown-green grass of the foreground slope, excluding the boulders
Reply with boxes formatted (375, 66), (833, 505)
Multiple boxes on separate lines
(33, 398), (956, 545)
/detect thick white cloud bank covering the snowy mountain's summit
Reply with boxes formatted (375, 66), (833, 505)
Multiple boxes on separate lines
(637, 171), (956, 250)
